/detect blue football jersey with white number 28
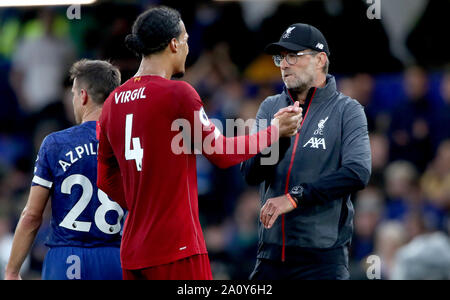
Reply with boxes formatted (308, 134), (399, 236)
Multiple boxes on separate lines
(32, 121), (124, 247)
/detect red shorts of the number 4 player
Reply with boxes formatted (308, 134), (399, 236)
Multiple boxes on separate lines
(123, 254), (212, 280)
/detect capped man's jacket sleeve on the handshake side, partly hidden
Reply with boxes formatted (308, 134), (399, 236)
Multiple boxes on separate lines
(241, 98), (291, 185)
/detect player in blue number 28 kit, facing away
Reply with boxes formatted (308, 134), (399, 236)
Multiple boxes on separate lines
(5, 60), (124, 280)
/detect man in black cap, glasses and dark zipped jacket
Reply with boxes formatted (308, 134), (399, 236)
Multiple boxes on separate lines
(241, 23), (371, 279)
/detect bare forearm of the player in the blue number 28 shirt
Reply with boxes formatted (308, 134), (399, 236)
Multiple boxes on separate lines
(5, 209), (42, 279)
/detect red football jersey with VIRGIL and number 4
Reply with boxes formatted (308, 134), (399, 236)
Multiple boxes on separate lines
(97, 75), (278, 269)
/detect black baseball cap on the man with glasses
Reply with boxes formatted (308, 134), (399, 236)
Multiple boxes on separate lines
(264, 23), (330, 56)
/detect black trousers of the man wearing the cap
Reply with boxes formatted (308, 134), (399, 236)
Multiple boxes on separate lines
(250, 259), (350, 280)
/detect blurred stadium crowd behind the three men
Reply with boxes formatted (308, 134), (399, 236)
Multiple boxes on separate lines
(0, 0), (450, 279)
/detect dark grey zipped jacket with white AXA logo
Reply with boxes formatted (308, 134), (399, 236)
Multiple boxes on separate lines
(241, 75), (371, 263)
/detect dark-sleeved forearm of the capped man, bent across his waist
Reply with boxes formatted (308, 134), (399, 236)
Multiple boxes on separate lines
(299, 164), (370, 206)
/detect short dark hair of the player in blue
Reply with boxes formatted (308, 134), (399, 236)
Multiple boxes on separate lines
(70, 59), (121, 105)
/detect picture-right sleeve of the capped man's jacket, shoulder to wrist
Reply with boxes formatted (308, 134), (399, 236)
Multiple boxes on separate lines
(300, 102), (372, 205)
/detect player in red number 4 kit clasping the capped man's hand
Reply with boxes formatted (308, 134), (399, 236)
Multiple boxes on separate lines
(97, 7), (302, 280)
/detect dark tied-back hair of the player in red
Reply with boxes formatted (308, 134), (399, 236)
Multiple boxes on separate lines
(125, 6), (181, 57)
